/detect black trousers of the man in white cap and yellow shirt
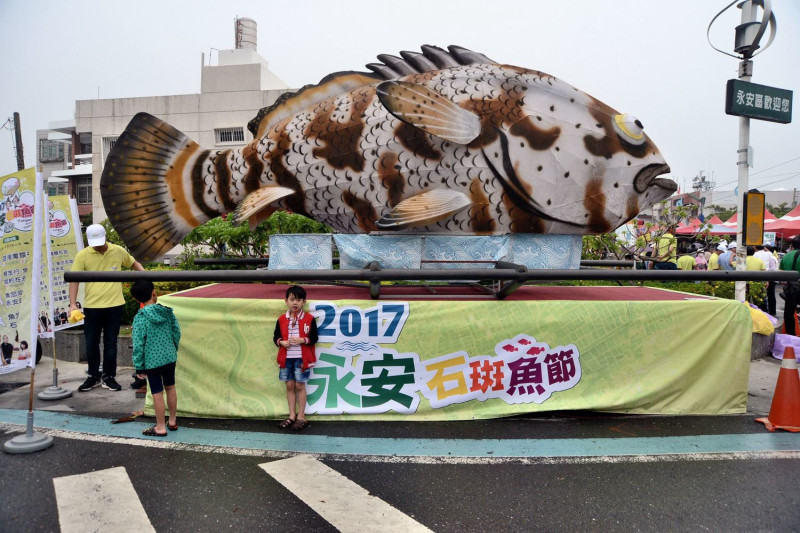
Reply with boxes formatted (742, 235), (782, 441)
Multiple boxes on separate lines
(83, 305), (124, 378)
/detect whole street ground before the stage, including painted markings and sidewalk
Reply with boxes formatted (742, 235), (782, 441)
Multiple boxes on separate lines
(0, 360), (800, 533)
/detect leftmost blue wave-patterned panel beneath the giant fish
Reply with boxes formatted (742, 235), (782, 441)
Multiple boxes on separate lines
(268, 233), (333, 270)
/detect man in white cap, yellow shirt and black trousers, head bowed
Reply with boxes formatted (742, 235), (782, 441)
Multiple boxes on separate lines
(69, 224), (144, 392)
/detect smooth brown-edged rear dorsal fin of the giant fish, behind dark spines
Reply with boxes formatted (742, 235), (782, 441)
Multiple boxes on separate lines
(247, 71), (383, 139)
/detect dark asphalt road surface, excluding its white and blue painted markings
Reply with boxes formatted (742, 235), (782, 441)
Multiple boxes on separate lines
(0, 415), (800, 532)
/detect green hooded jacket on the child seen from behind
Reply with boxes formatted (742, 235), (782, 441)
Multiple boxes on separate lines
(133, 304), (181, 372)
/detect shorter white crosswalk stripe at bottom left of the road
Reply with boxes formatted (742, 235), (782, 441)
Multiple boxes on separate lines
(53, 466), (155, 533)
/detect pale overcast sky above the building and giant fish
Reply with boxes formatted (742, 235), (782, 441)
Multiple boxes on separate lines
(0, 0), (800, 204)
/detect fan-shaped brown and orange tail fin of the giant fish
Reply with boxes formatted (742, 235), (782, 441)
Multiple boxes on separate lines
(100, 113), (212, 262)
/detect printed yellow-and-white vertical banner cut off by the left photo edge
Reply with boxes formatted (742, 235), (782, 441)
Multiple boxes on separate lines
(0, 168), (42, 373)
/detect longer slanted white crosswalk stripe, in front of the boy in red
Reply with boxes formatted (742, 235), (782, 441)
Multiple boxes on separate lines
(259, 455), (430, 533)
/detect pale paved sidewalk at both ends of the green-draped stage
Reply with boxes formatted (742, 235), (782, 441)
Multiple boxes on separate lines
(0, 357), (780, 418)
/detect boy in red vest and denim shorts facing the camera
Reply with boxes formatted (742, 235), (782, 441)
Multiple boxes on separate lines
(272, 285), (319, 431)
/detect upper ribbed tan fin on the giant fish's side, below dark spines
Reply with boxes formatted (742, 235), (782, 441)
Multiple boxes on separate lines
(376, 81), (481, 144)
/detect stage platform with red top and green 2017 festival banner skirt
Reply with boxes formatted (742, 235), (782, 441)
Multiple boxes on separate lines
(158, 283), (752, 420)
